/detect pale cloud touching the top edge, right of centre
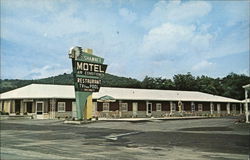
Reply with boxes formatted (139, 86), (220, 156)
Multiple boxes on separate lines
(142, 0), (212, 28)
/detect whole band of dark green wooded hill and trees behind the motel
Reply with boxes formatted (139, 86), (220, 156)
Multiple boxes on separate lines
(1, 73), (250, 100)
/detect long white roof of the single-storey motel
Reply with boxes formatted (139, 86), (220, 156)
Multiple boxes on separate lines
(0, 84), (241, 103)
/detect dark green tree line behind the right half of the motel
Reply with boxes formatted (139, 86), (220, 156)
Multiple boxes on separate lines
(141, 73), (250, 100)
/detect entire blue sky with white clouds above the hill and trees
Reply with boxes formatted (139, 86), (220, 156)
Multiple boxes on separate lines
(1, 0), (250, 80)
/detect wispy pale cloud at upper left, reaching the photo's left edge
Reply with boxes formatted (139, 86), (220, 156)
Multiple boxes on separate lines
(1, 6), (89, 39)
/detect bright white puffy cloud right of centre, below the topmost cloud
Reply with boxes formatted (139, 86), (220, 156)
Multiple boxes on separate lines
(141, 23), (213, 56)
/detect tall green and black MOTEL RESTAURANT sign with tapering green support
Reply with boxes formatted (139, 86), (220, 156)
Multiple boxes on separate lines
(69, 47), (107, 120)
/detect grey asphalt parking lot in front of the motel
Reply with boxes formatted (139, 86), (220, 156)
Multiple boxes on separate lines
(1, 118), (250, 160)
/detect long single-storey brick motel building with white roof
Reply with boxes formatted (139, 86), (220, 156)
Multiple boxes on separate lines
(0, 84), (244, 119)
